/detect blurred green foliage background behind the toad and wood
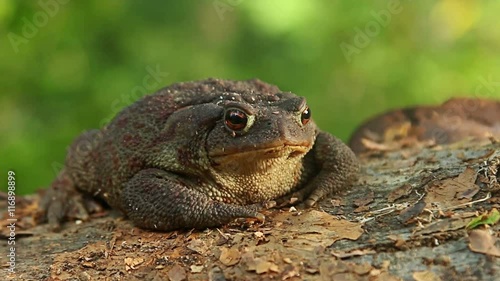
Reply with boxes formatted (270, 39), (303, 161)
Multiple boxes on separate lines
(0, 0), (500, 194)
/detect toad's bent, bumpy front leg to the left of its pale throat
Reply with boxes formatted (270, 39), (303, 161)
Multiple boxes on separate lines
(120, 169), (264, 231)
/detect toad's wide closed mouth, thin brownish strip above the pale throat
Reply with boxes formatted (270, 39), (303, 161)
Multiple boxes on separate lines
(209, 144), (311, 164)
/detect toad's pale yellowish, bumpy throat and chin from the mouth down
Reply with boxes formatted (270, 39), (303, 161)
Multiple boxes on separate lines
(206, 145), (311, 201)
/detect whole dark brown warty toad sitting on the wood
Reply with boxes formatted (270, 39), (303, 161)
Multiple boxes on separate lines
(41, 79), (358, 231)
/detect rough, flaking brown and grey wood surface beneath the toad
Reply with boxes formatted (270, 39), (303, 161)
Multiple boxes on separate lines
(0, 138), (500, 280)
